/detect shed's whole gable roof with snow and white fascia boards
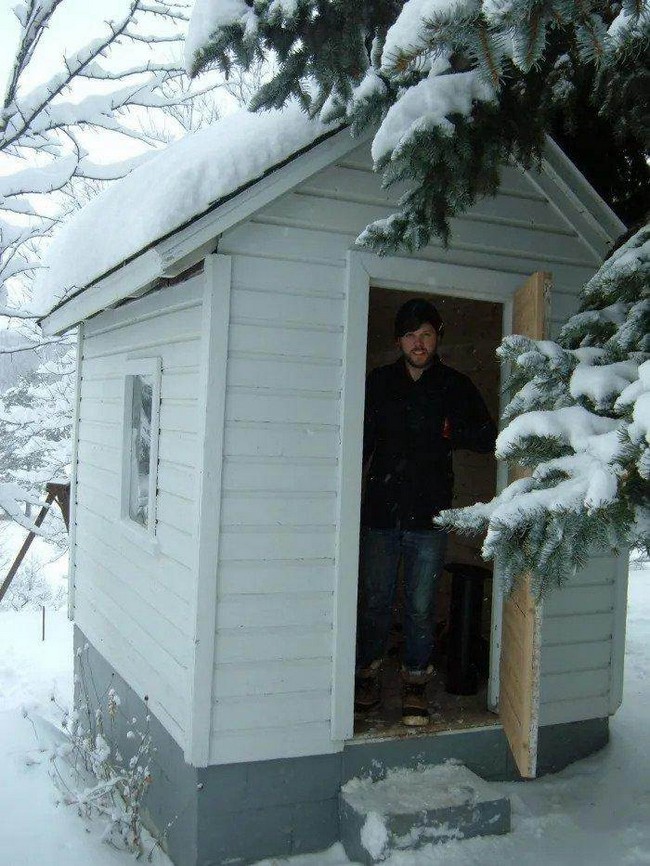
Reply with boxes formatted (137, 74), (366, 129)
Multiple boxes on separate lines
(40, 108), (624, 334)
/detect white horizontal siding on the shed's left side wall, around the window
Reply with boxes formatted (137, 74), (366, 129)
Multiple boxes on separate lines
(70, 276), (203, 744)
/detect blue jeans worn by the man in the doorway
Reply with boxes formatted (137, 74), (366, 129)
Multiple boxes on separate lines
(357, 528), (447, 673)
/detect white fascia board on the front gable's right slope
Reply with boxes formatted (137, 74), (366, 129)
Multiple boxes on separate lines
(527, 135), (626, 262)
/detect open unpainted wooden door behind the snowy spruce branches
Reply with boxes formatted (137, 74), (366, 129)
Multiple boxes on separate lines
(499, 271), (551, 779)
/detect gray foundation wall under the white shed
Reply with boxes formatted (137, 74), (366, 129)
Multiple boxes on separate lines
(75, 627), (609, 866)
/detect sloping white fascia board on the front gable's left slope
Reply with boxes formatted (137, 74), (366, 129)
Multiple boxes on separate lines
(156, 128), (364, 276)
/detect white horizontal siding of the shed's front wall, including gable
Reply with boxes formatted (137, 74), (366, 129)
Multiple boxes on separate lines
(210, 138), (615, 763)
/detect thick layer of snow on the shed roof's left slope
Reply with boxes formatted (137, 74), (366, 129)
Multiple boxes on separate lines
(34, 105), (335, 315)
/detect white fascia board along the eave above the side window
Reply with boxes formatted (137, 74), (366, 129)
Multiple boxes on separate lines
(40, 250), (164, 337)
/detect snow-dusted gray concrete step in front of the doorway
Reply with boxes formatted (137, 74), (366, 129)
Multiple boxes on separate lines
(340, 761), (510, 864)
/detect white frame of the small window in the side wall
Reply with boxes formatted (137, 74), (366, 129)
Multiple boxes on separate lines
(120, 357), (162, 546)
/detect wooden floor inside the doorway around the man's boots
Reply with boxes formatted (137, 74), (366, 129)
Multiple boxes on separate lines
(354, 658), (500, 740)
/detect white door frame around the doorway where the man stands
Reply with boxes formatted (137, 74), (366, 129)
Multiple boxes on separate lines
(331, 250), (527, 741)
